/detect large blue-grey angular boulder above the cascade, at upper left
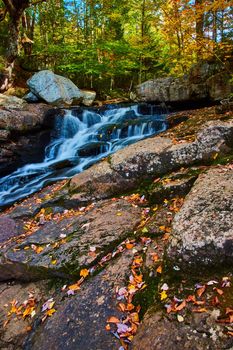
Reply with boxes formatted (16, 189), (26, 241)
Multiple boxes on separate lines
(27, 70), (82, 105)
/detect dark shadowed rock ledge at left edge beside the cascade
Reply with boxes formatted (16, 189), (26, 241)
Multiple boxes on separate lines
(0, 102), (56, 175)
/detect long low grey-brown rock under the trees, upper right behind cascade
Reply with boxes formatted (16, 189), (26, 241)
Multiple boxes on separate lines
(137, 63), (233, 103)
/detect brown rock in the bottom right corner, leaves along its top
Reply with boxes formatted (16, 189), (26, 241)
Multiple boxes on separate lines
(133, 310), (233, 350)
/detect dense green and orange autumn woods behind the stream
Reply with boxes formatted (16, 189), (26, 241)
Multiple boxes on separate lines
(0, 0), (233, 91)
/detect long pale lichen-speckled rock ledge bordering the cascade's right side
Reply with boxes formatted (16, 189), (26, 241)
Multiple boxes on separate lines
(70, 122), (233, 201)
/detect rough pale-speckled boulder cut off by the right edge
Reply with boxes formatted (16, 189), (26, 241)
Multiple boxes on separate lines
(167, 165), (233, 269)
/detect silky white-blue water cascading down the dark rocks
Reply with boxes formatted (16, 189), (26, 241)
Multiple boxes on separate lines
(0, 105), (167, 207)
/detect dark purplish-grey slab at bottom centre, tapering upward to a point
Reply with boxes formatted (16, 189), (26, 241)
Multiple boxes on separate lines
(24, 251), (132, 350)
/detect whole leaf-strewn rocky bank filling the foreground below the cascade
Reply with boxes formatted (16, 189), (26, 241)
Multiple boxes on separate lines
(0, 99), (233, 350)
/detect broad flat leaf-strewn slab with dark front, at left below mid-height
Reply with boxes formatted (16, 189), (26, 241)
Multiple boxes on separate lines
(0, 199), (141, 281)
